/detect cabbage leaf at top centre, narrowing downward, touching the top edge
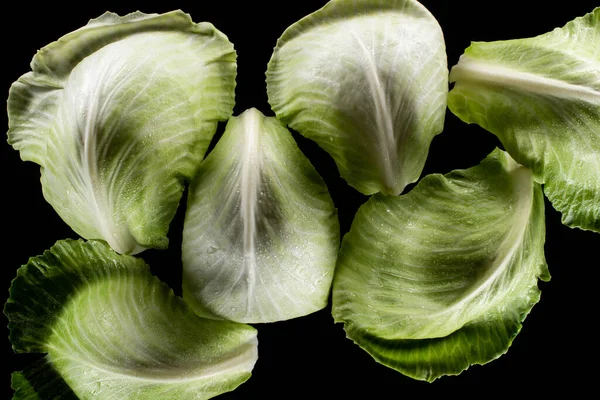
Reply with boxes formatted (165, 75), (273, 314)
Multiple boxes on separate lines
(267, 0), (448, 195)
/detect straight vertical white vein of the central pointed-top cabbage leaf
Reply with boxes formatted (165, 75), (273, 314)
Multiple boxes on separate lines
(241, 112), (260, 312)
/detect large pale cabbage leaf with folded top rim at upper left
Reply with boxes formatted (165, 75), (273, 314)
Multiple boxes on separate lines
(8, 11), (236, 254)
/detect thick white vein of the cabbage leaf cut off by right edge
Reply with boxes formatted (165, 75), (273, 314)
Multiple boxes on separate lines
(450, 56), (600, 103)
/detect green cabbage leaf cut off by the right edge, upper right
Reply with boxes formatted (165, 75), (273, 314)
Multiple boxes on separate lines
(448, 8), (600, 232)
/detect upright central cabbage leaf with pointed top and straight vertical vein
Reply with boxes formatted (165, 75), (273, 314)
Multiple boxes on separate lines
(182, 109), (340, 323)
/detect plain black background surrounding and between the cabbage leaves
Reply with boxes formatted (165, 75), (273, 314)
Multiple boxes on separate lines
(0, 0), (600, 400)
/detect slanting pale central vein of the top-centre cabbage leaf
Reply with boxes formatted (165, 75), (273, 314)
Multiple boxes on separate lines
(352, 32), (396, 188)
